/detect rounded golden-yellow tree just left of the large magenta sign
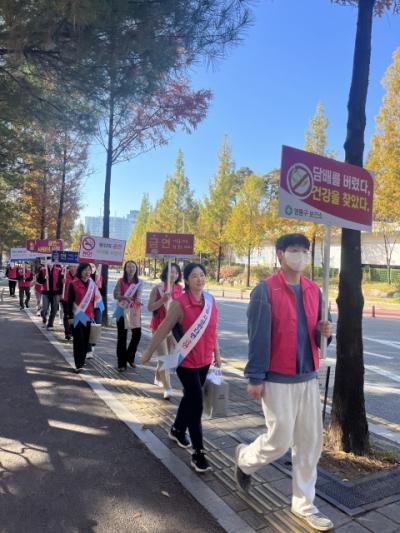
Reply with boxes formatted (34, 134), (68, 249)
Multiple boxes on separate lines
(225, 174), (266, 287)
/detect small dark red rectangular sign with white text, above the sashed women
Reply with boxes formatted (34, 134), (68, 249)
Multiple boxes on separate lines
(146, 233), (194, 258)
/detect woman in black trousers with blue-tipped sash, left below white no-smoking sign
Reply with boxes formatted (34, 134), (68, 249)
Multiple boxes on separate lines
(67, 263), (96, 373)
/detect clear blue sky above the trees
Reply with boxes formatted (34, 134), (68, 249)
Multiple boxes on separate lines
(81, 0), (400, 219)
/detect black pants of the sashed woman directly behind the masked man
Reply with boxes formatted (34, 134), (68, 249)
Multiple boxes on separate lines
(174, 365), (210, 452)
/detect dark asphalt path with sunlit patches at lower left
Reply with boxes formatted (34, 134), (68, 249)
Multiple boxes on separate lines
(0, 298), (224, 533)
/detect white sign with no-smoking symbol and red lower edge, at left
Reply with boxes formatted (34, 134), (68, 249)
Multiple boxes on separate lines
(78, 235), (126, 265)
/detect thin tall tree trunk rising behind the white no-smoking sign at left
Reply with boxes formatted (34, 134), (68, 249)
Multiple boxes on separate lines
(101, 93), (114, 326)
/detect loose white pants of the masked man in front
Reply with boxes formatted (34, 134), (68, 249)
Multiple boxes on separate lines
(238, 379), (322, 515)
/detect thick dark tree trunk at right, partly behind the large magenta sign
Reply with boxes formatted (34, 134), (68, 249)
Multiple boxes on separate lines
(329, 0), (375, 455)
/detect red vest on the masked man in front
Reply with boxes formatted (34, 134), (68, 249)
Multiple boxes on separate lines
(264, 272), (319, 376)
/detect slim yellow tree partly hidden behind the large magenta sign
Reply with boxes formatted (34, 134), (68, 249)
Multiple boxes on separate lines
(304, 102), (336, 279)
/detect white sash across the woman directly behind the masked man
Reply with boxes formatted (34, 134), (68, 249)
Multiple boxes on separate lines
(158, 291), (213, 370)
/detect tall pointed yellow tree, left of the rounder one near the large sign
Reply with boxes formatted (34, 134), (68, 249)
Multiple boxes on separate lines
(196, 136), (235, 281)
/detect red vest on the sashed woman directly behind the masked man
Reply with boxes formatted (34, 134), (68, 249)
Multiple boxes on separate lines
(177, 291), (218, 368)
